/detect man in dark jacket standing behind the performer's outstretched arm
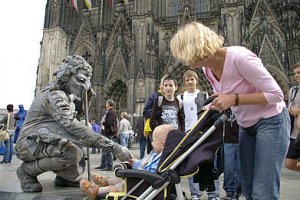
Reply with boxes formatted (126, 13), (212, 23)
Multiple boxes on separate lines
(95, 99), (118, 171)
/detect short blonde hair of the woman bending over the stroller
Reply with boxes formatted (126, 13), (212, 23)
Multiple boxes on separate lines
(170, 22), (224, 65)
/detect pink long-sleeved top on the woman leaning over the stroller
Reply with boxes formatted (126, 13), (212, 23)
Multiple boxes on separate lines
(203, 46), (285, 128)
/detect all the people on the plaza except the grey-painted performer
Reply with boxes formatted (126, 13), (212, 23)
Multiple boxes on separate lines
(0, 22), (300, 200)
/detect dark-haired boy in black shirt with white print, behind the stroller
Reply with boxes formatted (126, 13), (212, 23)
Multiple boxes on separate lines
(150, 76), (185, 133)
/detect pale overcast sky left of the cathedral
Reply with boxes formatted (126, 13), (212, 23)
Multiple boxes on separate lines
(0, 0), (46, 109)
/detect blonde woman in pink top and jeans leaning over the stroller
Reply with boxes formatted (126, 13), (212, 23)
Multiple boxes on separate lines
(170, 22), (290, 200)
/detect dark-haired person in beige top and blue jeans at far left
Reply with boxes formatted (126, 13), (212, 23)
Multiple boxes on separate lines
(0, 104), (16, 164)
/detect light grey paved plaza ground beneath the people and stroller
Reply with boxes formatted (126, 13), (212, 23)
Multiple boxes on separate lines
(0, 144), (300, 200)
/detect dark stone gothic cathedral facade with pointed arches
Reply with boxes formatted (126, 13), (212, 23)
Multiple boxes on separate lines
(36, 0), (300, 120)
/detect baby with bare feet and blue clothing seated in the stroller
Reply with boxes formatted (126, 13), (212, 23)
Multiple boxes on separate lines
(80, 124), (174, 199)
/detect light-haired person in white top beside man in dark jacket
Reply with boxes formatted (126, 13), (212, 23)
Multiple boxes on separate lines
(119, 112), (131, 147)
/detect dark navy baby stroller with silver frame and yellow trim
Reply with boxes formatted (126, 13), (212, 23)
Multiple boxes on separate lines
(100, 99), (230, 200)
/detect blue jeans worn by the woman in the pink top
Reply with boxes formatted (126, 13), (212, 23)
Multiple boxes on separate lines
(239, 108), (291, 200)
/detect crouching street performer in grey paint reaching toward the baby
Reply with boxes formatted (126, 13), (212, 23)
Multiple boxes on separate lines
(16, 55), (132, 192)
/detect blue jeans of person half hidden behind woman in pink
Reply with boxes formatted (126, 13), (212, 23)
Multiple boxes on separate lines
(223, 143), (241, 196)
